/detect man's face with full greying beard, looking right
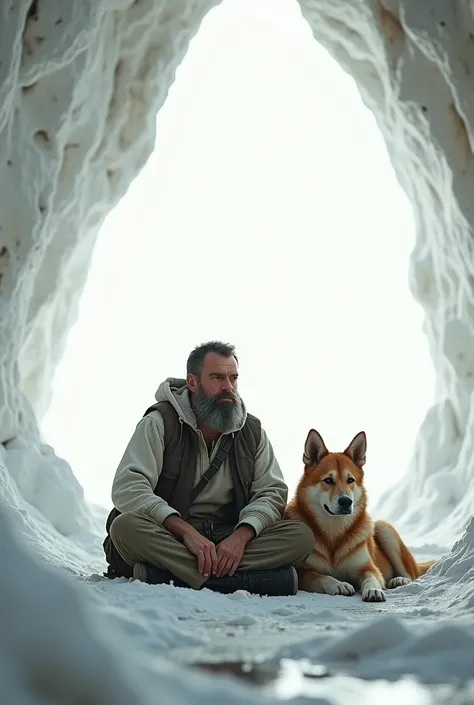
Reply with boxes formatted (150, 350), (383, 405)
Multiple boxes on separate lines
(187, 352), (243, 433)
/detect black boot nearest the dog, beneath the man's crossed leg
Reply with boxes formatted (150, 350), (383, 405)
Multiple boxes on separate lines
(203, 568), (298, 597)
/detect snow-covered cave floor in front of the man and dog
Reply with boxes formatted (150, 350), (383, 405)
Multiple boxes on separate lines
(0, 490), (474, 705)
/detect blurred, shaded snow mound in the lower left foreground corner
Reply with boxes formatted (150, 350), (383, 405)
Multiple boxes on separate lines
(0, 504), (146, 705)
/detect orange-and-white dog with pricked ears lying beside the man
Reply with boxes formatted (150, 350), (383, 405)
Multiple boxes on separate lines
(285, 429), (435, 602)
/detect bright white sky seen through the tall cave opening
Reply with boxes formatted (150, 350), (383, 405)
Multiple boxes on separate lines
(43, 0), (434, 507)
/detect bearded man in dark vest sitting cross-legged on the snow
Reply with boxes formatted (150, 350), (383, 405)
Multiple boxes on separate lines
(104, 341), (314, 595)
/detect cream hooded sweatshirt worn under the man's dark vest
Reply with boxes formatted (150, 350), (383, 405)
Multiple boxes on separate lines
(112, 377), (288, 536)
